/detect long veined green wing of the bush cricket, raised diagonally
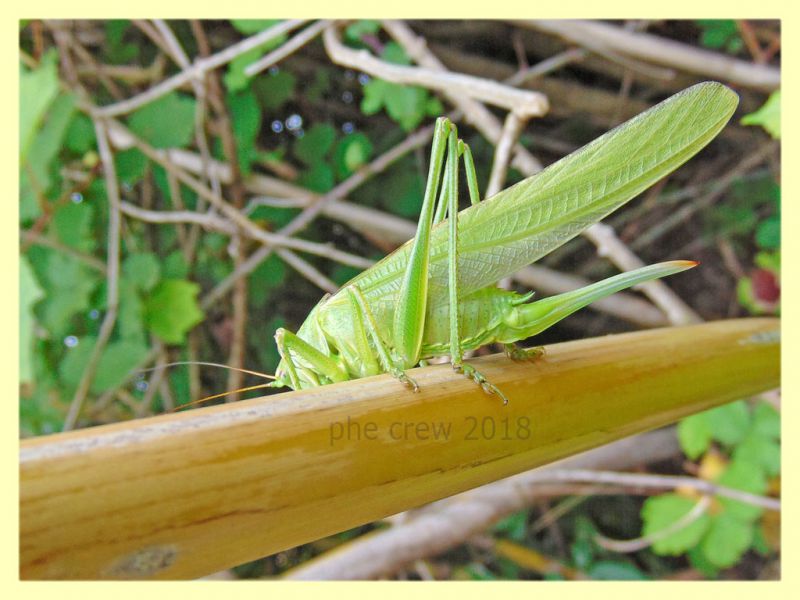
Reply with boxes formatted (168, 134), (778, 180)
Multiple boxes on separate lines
(346, 82), (738, 308)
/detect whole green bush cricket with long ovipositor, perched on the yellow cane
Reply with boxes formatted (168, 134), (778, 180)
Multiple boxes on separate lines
(181, 82), (738, 403)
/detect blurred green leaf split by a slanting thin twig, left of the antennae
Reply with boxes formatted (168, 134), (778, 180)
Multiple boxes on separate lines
(59, 337), (148, 394)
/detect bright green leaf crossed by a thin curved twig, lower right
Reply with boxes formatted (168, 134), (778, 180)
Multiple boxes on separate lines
(642, 494), (710, 556)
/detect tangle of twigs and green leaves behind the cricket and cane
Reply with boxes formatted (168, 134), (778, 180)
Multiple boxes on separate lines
(19, 20), (780, 579)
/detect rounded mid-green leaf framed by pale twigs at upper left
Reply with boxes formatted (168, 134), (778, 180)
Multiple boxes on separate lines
(128, 92), (196, 148)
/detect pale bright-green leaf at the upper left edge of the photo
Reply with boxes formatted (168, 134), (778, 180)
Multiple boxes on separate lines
(19, 49), (58, 164)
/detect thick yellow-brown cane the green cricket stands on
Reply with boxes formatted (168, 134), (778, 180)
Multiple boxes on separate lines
(20, 319), (780, 579)
